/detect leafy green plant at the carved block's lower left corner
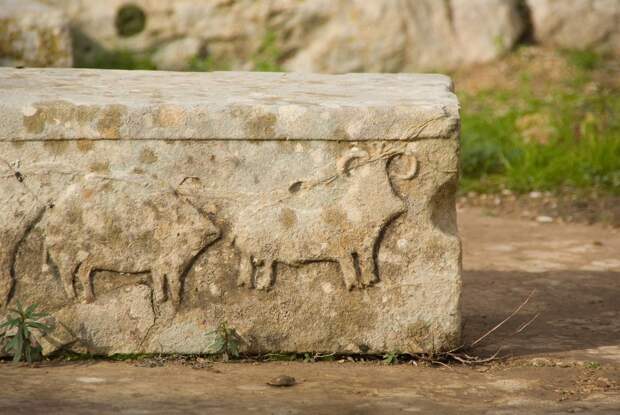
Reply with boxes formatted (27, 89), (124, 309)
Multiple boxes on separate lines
(0, 301), (52, 363)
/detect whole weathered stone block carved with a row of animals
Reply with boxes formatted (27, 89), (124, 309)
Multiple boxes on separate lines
(0, 69), (461, 354)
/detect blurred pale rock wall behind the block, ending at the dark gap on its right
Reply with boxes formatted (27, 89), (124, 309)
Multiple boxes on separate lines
(40, 0), (525, 73)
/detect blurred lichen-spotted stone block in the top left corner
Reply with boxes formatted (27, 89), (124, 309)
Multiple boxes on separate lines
(0, 0), (73, 67)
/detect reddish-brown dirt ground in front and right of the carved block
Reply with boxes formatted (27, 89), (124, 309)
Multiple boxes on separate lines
(0, 207), (620, 414)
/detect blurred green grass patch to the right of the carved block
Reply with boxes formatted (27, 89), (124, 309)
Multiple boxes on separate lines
(460, 52), (620, 194)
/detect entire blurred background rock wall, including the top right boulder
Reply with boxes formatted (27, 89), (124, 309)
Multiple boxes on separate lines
(0, 0), (620, 73)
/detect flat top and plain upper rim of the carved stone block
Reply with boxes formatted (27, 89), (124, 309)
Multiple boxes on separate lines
(0, 69), (459, 141)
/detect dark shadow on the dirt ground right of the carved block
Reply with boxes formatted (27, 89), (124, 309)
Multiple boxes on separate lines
(463, 271), (620, 359)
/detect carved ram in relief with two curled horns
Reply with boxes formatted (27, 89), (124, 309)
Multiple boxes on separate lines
(233, 148), (417, 290)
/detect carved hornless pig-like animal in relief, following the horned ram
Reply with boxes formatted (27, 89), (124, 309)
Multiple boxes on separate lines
(3, 175), (220, 305)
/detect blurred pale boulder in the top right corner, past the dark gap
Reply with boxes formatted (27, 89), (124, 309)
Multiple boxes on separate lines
(527, 0), (620, 55)
